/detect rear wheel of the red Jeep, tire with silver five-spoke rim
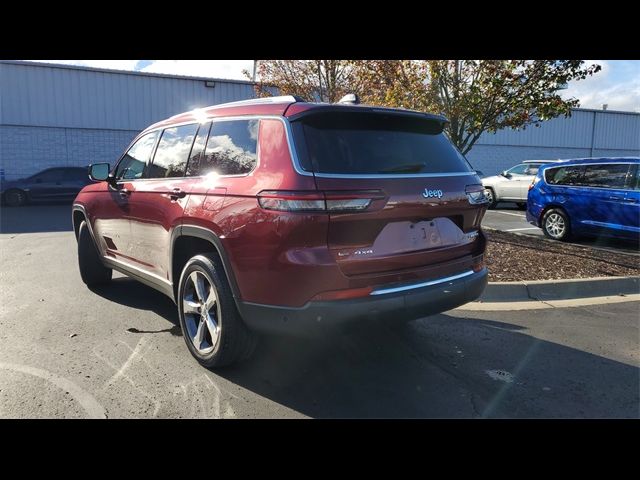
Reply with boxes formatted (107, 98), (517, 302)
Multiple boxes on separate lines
(177, 253), (256, 368)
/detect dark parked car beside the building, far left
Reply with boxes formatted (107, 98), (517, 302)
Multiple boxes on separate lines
(0, 167), (91, 207)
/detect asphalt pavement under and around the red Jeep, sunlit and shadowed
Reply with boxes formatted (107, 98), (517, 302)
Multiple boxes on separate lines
(0, 205), (640, 418)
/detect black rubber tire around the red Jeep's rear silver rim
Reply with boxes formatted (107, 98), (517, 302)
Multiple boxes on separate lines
(176, 253), (257, 368)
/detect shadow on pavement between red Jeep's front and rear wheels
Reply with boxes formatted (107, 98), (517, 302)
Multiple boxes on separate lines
(90, 277), (182, 336)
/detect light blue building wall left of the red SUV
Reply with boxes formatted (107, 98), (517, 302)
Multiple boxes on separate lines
(0, 61), (254, 180)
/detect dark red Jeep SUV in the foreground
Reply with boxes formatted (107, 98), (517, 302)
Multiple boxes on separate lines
(73, 97), (487, 367)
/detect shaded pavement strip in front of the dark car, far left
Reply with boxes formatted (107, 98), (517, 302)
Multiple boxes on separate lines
(0, 202), (73, 233)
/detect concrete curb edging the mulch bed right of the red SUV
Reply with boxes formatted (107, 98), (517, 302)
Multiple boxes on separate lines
(480, 276), (640, 302)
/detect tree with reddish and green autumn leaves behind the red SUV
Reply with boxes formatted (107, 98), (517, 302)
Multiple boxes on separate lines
(246, 60), (601, 154)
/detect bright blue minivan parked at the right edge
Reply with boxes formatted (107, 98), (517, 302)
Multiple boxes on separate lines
(527, 157), (640, 240)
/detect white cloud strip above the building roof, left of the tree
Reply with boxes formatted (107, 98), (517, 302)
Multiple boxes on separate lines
(141, 60), (253, 80)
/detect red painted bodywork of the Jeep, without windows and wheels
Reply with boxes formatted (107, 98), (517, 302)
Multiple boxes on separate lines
(75, 99), (485, 307)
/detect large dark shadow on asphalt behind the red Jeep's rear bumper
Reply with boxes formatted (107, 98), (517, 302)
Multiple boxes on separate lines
(215, 313), (640, 418)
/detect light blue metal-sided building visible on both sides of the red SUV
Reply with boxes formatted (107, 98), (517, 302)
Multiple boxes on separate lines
(0, 61), (640, 179)
